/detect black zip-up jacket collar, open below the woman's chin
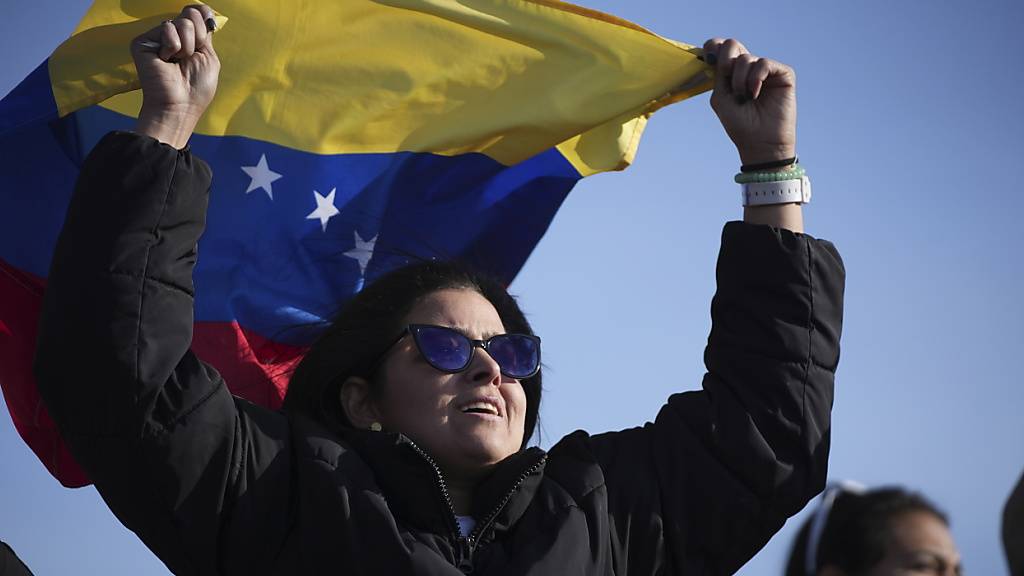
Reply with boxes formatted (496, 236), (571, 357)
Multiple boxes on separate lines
(344, 429), (547, 538)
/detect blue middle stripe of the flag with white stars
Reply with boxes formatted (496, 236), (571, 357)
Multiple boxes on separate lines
(0, 101), (580, 345)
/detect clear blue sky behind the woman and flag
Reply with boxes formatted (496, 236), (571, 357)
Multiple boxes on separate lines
(0, 0), (1024, 576)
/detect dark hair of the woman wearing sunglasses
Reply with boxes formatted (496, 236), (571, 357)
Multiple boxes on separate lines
(284, 260), (543, 447)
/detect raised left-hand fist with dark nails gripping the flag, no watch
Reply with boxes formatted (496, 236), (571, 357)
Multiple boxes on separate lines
(131, 4), (220, 149)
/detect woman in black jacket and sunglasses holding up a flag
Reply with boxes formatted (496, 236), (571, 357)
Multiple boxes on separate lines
(36, 6), (844, 574)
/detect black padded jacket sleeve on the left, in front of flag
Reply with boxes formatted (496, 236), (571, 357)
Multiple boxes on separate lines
(35, 132), (290, 574)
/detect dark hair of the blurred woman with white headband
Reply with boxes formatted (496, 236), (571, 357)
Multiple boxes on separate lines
(785, 487), (949, 576)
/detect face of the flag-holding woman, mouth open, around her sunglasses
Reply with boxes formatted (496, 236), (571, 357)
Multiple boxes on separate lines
(376, 289), (526, 479)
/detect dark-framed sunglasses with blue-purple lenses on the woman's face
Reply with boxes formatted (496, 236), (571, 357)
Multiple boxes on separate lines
(396, 324), (541, 380)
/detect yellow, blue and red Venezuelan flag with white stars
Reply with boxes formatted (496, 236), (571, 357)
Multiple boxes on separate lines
(0, 0), (710, 486)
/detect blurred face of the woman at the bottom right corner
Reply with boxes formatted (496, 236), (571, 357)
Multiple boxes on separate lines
(869, 511), (961, 576)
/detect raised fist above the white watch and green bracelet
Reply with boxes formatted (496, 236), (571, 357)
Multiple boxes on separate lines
(703, 38), (797, 164)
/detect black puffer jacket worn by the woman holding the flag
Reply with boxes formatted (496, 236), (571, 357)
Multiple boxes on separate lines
(36, 133), (844, 575)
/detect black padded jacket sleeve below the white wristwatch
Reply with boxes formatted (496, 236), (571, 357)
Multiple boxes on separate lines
(588, 222), (845, 574)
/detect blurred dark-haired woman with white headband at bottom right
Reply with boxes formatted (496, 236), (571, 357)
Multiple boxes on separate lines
(785, 486), (962, 576)
